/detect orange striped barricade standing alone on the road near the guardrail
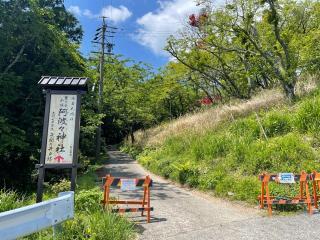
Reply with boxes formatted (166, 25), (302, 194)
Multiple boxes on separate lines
(101, 175), (153, 223)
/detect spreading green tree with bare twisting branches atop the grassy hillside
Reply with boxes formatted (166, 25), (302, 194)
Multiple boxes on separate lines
(167, 0), (319, 99)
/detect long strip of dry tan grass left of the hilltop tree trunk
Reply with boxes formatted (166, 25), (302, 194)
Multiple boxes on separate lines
(135, 90), (285, 148)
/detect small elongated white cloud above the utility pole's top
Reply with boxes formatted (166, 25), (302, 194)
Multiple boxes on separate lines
(68, 5), (132, 23)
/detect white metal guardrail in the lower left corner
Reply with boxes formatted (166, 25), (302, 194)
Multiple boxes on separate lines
(0, 192), (74, 240)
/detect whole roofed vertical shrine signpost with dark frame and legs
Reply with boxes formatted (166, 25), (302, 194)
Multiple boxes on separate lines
(36, 76), (89, 202)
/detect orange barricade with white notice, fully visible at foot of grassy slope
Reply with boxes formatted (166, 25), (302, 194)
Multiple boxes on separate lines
(258, 172), (313, 216)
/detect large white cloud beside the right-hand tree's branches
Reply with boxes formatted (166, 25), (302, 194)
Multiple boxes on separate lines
(134, 0), (200, 56)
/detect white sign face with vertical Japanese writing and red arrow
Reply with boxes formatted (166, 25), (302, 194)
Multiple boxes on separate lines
(45, 94), (77, 164)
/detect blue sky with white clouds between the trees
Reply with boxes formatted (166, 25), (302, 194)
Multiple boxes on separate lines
(65, 0), (199, 69)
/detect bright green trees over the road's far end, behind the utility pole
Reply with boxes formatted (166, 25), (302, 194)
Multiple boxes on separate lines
(86, 56), (197, 144)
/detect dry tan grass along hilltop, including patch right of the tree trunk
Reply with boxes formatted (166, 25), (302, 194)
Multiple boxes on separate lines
(130, 75), (320, 149)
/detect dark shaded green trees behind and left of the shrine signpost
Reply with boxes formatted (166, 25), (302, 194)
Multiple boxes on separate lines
(0, 0), (85, 189)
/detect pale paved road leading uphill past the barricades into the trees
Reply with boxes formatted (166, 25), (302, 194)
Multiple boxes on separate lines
(105, 150), (320, 240)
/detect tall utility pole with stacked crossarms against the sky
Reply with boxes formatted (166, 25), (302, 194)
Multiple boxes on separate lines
(93, 17), (117, 161)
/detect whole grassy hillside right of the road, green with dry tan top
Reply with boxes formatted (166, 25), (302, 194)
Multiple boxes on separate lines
(125, 84), (320, 203)
